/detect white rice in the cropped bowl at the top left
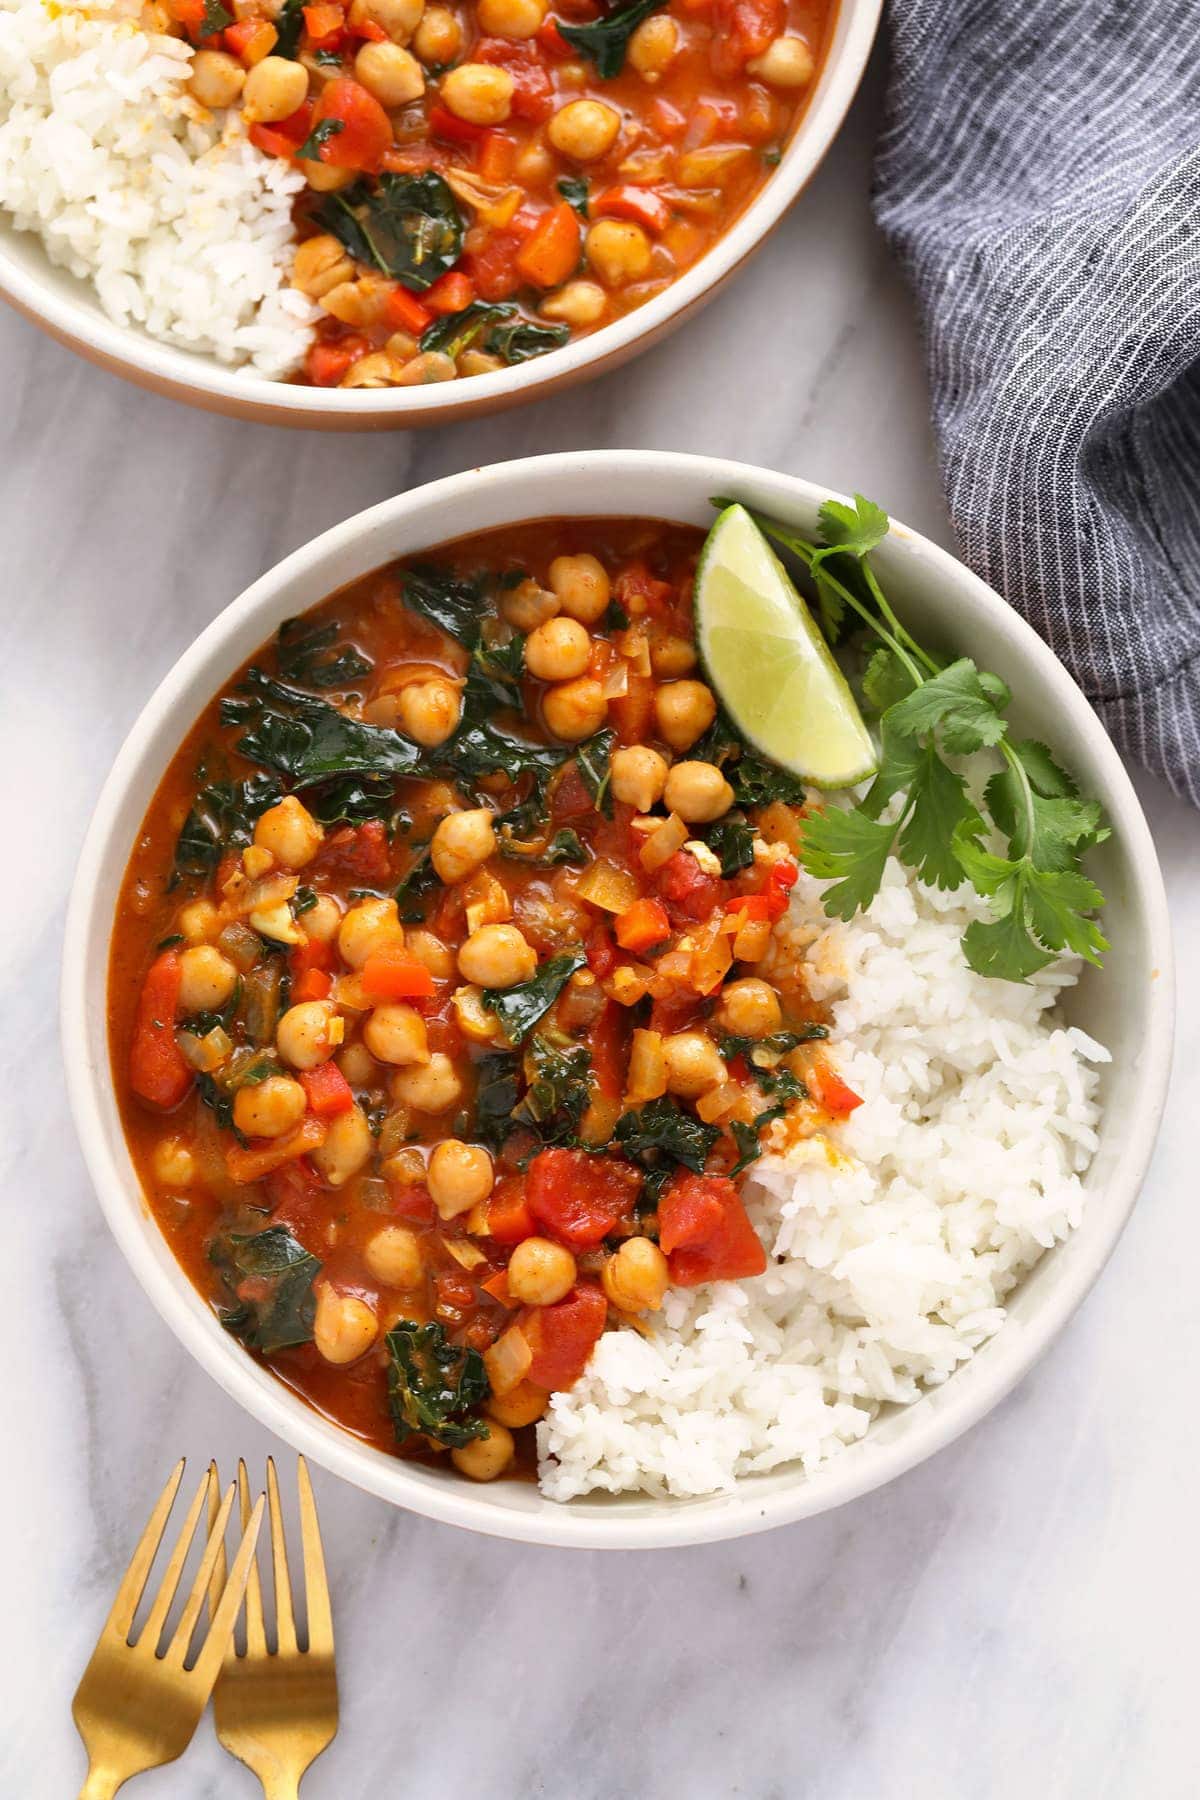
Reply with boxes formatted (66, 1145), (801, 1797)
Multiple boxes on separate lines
(0, 0), (317, 378)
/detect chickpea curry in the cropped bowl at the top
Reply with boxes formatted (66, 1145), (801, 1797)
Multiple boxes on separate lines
(176, 0), (833, 387)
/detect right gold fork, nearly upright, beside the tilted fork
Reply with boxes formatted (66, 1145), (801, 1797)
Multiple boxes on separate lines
(209, 1456), (338, 1800)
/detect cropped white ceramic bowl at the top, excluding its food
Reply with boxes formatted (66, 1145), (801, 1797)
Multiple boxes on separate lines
(0, 0), (883, 430)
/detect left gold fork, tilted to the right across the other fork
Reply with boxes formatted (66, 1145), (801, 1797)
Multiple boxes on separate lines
(72, 1462), (263, 1800)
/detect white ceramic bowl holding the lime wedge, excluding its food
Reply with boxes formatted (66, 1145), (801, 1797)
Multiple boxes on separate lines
(63, 450), (1173, 1548)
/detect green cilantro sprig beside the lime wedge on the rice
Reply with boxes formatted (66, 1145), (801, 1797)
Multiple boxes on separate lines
(716, 495), (1110, 981)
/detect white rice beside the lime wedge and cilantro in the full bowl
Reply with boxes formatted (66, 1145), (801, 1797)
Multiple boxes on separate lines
(538, 862), (1108, 1499)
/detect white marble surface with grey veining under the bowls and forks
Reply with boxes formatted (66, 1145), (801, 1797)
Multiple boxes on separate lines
(0, 56), (1200, 1800)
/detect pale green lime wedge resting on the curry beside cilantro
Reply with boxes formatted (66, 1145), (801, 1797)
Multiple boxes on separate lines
(696, 506), (876, 788)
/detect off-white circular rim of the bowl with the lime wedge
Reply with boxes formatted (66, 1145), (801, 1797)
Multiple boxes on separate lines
(59, 450), (1175, 1548)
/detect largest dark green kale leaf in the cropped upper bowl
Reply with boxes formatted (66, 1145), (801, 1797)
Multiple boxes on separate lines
(313, 169), (462, 293)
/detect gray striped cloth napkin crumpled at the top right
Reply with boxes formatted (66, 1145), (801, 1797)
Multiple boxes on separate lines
(876, 0), (1200, 805)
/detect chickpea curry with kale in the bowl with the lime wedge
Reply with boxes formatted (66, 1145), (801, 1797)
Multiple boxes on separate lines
(110, 520), (858, 1480)
